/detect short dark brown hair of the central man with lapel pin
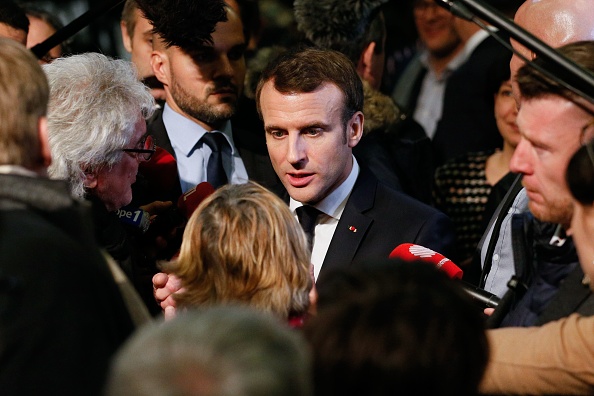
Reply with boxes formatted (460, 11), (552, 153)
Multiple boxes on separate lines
(256, 47), (363, 123)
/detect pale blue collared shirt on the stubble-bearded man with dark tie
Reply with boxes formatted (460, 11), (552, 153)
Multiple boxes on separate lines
(163, 103), (248, 193)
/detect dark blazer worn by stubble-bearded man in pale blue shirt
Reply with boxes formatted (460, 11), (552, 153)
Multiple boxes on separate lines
(139, 106), (286, 203)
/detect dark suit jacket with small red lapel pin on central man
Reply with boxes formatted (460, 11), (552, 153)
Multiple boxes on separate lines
(316, 167), (455, 288)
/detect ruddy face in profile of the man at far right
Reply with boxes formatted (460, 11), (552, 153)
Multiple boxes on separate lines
(510, 96), (591, 227)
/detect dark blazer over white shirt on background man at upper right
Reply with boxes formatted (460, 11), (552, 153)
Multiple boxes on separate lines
(433, 36), (511, 167)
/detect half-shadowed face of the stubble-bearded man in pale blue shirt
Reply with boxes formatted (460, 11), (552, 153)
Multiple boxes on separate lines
(153, 11), (245, 130)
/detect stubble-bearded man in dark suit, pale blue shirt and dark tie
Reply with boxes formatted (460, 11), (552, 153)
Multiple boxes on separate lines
(138, 0), (282, 201)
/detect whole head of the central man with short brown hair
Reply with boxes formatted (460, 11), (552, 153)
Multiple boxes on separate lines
(256, 48), (364, 204)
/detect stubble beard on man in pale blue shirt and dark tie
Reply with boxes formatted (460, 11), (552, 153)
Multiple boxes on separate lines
(171, 79), (237, 128)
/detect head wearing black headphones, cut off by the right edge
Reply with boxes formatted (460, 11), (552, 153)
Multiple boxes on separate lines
(565, 138), (594, 288)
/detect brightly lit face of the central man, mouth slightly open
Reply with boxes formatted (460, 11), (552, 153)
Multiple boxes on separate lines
(260, 81), (363, 204)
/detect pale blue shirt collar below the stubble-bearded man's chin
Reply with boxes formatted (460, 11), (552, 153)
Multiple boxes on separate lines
(163, 103), (235, 156)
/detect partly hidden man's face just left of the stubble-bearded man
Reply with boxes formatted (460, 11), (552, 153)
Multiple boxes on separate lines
(122, 9), (154, 79)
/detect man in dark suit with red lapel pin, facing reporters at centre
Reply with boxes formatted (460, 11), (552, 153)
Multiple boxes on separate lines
(256, 48), (453, 286)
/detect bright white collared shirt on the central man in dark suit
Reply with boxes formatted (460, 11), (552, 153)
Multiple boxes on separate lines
(289, 157), (359, 280)
